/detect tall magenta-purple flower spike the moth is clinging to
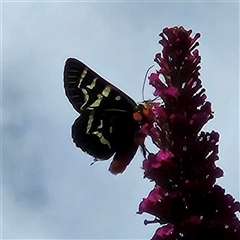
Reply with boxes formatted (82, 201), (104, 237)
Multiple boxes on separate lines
(138, 27), (240, 240)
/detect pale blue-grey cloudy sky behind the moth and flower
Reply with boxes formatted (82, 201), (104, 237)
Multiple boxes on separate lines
(1, 1), (240, 239)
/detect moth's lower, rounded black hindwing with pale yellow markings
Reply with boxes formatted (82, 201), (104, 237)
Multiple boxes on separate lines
(72, 105), (139, 160)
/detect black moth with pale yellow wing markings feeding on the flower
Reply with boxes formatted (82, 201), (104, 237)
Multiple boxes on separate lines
(64, 58), (144, 174)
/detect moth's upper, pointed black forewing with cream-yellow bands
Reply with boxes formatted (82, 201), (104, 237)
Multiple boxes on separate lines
(64, 58), (136, 113)
